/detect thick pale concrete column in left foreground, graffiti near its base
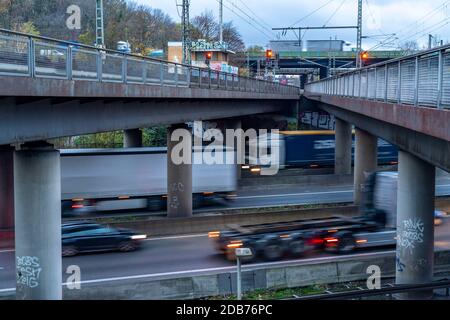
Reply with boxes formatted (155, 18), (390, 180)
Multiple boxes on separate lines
(14, 143), (62, 300)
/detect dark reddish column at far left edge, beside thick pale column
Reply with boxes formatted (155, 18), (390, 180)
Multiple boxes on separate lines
(0, 146), (14, 231)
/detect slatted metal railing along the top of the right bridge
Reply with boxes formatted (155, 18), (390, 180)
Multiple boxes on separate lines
(305, 45), (450, 109)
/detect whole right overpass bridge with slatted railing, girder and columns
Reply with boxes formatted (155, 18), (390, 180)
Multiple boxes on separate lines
(305, 46), (450, 297)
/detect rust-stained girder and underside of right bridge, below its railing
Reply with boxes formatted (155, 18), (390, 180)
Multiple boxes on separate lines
(306, 93), (450, 171)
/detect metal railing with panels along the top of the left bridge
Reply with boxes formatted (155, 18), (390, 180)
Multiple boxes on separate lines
(0, 29), (300, 95)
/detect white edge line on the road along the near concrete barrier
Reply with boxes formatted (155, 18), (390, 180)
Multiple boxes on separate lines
(0, 250), (395, 292)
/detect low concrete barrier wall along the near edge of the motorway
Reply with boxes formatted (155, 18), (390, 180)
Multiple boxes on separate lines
(0, 251), (450, 300)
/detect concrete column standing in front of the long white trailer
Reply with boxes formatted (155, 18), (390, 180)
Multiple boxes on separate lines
(167, 125), (192, 218)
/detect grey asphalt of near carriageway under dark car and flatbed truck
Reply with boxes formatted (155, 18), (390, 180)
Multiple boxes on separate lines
(0, 218), (450, 292)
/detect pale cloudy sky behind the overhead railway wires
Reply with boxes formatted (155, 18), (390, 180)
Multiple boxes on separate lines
(135, 0), (450, 49)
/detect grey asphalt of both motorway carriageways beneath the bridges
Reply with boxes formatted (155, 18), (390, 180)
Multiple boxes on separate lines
(0, 179), (450, 292)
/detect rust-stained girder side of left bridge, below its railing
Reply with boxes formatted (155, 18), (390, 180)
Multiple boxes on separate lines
(0, 76), (300, 145)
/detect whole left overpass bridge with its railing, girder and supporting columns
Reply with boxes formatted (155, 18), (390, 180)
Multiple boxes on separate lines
(0, 30), (300, 299)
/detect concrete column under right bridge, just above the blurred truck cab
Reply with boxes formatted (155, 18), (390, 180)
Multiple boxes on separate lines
(354, 128), (378, 205)
